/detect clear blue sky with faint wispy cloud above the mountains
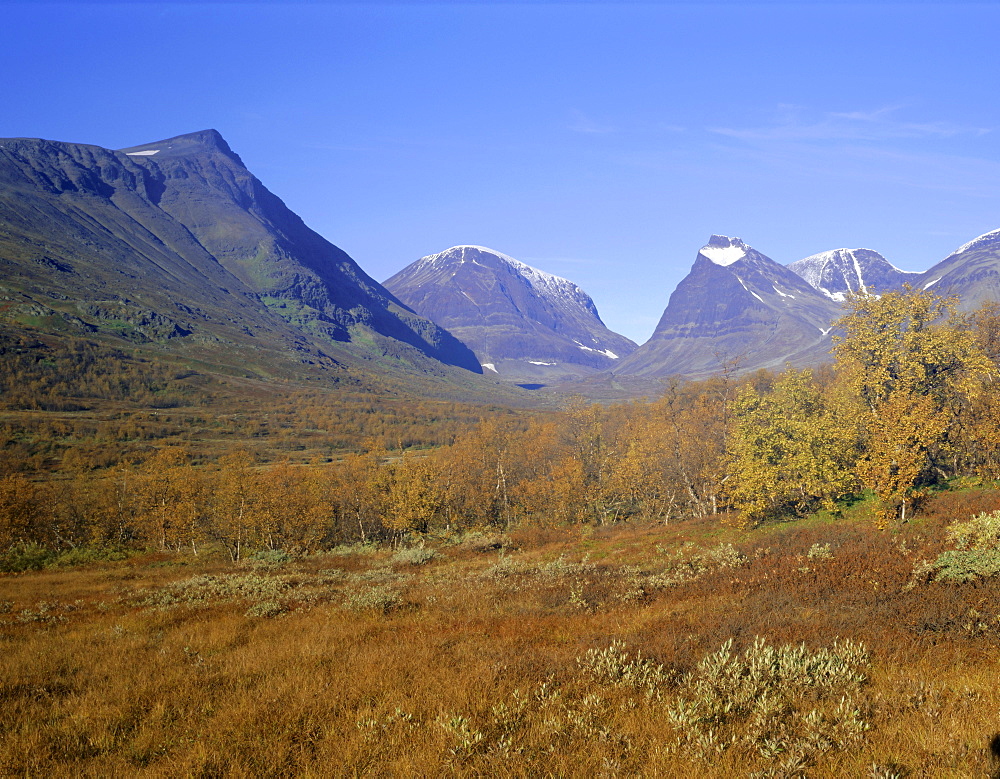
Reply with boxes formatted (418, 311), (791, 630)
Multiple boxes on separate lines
(0, 1), (1000, 342)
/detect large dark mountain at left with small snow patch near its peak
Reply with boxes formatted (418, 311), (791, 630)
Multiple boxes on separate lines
(0, 130), (481, 372)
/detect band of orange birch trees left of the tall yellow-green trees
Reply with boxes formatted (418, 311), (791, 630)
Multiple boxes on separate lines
(0, 388), (728, 559)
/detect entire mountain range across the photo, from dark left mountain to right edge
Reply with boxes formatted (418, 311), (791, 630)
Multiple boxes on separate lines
(0, 130), (1000, 392)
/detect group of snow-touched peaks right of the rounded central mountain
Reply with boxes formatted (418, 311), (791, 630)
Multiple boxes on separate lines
(613, 230), (1000, 378)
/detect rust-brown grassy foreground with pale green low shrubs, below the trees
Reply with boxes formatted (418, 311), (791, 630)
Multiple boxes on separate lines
(0, 491), (1000, 777)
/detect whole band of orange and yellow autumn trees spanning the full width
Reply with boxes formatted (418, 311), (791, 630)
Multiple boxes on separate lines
(0, 290), (1000, 559)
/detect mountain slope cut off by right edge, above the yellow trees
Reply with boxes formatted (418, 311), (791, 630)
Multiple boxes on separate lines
(914, 230), (1000, 311)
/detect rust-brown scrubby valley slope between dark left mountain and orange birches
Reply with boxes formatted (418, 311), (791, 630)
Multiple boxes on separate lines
(0, 328), (517, 478)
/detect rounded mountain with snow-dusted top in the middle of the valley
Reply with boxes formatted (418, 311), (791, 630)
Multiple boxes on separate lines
(384, 246), (636, 381)
